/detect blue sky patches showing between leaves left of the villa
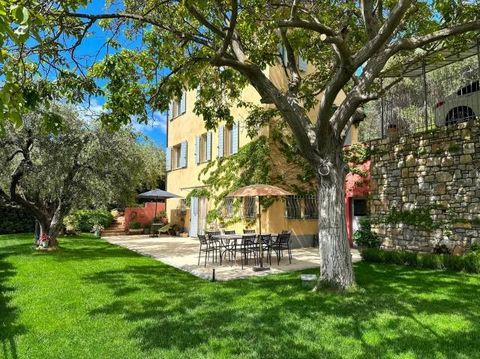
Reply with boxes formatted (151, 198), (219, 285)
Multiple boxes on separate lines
(75, 0), (167, 148)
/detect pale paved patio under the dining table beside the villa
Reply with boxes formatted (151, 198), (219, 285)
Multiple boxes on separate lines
(103, 235), (360, 281)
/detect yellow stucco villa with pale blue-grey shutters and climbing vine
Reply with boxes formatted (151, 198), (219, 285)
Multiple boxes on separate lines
(166, 65), (356, 247)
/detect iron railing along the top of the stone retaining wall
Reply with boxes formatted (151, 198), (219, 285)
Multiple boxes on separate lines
(359, 58), (480, 142)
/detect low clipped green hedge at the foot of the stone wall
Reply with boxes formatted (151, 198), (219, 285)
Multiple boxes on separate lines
(361, 248), (480, 273)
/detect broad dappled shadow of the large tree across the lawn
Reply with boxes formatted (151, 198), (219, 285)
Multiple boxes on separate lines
(86, 264), (480, 358)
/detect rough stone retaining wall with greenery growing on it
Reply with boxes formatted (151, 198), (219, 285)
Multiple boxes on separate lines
(370, 122), (480, 254)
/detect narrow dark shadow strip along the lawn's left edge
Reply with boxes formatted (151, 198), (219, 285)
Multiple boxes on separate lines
(0, 255), (26, 359)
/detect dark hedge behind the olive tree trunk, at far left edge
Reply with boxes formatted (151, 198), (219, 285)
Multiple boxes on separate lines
(0, 202), (35, 234)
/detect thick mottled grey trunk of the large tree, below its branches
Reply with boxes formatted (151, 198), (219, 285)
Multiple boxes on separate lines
(317, 143), (355, 290)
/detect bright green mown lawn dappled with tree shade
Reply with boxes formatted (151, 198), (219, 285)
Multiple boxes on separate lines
(0, 235), (480, 358)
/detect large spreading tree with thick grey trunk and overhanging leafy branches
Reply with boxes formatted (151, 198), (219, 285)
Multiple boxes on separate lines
(4, 0), (480, 289)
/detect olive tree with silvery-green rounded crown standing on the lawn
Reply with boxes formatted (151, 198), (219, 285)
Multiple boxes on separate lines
(0, 108), (164, 247)
